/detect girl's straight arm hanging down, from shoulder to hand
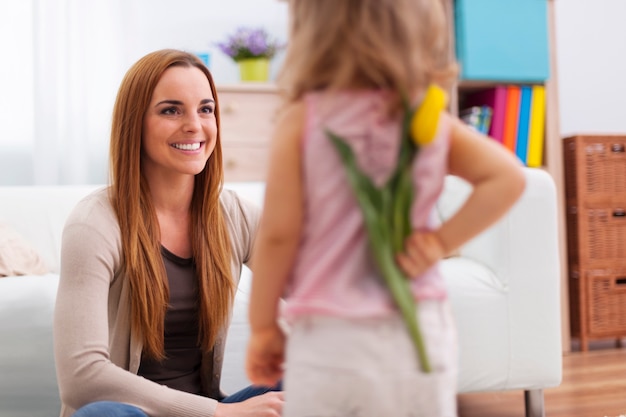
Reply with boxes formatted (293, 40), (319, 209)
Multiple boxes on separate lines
(247, 102), (305, 385)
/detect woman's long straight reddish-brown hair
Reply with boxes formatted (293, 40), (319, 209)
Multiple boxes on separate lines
(110, 49), (234, 359)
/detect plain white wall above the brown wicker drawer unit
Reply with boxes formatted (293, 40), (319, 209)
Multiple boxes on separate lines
(555, 0), (626, 136)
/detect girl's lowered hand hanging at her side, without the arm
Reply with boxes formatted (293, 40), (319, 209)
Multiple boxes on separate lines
(246, 324), (285, 387)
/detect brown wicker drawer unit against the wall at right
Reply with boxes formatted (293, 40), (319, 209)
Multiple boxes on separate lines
(563, 135), (626, 351)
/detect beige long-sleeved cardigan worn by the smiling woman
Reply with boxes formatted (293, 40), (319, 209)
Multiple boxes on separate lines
(54, 188), (260, 417)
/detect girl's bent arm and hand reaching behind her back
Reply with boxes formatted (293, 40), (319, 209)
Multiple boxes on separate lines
(398, 114), (526, 277)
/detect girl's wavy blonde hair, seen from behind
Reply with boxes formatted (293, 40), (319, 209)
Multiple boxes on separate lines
(278, 0), (457, 105)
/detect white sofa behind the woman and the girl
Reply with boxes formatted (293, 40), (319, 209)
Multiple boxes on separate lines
(0, 168), (562, 417)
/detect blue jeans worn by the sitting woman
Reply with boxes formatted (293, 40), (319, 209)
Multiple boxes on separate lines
(72, 383), (282, 417)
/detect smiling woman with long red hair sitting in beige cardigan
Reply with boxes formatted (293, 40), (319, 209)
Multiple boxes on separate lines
(54, 49), (282, 417)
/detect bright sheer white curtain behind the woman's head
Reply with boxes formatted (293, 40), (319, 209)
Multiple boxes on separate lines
(28, 0), (134, 184)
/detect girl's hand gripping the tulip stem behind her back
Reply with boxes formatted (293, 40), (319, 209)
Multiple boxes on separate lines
(396, 231), (446, 278)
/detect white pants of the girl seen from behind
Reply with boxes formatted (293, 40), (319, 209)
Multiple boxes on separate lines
(283, 301), (457, 417)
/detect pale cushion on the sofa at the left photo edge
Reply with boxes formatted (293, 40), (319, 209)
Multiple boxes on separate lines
(0, 223), (50, 277)
